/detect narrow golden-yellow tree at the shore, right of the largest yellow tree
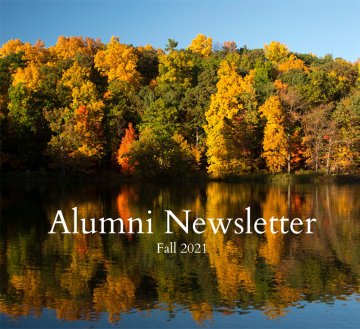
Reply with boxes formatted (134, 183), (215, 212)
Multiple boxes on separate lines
(259, 96), (287, 173)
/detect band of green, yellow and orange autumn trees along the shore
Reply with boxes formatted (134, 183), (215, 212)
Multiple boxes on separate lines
(0, 34), (360, 178)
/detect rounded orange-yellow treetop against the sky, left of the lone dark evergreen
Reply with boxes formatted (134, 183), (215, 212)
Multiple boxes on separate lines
(95, 36), (140, 87)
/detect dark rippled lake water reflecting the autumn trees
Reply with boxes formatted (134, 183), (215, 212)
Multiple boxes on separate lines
(0, 182), (360, 328)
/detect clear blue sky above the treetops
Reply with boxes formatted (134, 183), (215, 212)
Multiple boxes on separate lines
(0, 0), (360, 62)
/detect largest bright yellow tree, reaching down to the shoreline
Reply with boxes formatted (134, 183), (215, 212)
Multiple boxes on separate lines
(204, 60), (256, 177)
